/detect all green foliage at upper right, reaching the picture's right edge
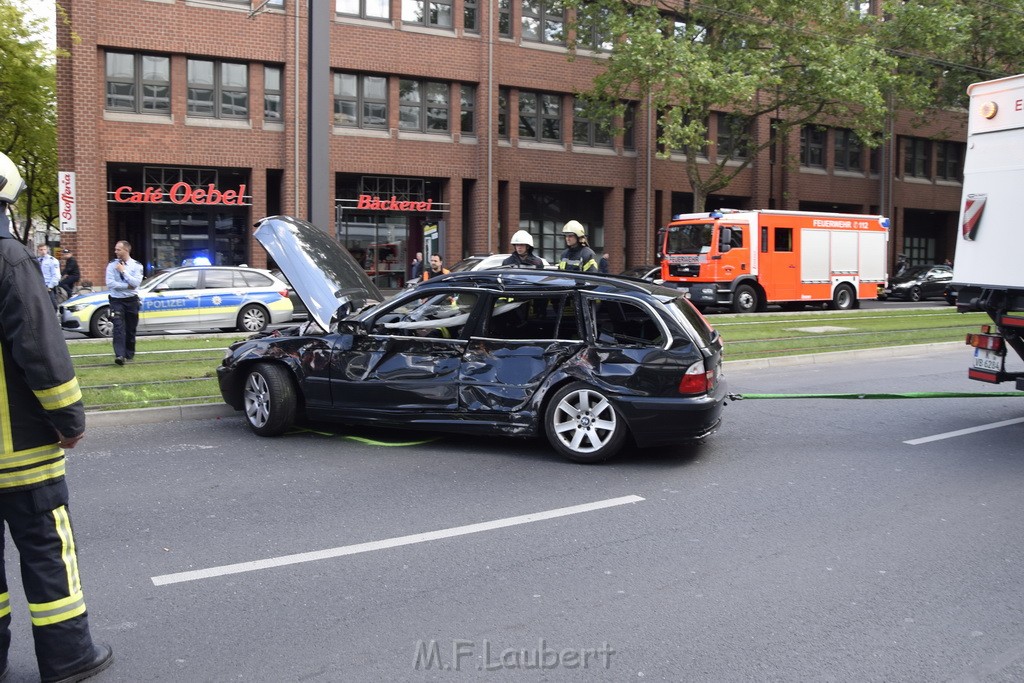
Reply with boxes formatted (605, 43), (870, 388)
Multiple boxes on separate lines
(568, 0), (1024, 211)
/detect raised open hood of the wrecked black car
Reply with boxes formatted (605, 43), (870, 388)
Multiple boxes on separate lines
(253, 216), (384, 330)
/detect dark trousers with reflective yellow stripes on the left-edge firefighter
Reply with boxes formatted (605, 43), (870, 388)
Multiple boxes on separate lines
(0, 480), (93, 680)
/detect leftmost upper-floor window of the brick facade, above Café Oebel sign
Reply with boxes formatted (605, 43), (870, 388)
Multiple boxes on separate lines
(106, 52), (171, 114)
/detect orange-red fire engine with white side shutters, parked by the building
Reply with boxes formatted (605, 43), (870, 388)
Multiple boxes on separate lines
(658, 209), (889, 312)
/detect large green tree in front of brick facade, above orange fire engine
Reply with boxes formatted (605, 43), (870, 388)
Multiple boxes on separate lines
(571, 0), (899, 211)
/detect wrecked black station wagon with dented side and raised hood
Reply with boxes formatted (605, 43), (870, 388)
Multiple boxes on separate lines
(217, 216), (726, 462)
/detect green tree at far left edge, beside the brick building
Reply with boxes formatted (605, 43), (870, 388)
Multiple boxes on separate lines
(0, 0), (57, 242)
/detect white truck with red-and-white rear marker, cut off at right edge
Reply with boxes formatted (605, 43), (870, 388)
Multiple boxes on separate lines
(953, 75), (1024, 390)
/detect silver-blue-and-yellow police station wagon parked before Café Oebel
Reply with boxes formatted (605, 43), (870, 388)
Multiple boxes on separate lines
(60, 266), (292, 337)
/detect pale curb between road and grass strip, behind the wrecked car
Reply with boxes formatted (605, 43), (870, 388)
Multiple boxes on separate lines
(85, 342), (964, 427)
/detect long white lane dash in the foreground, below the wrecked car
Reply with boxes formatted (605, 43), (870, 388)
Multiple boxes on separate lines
(153, 496), (644, 586)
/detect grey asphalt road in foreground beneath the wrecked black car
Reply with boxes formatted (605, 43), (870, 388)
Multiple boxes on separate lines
(7, 347), (1024, 683)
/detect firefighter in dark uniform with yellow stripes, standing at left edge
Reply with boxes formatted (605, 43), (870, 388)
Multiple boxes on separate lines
(0, 154), (114, 683)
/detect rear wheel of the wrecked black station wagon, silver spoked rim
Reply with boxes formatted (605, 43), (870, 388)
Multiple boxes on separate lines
(544, 382), (628, 463)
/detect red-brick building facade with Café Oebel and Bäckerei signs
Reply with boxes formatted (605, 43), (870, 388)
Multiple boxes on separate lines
(57, 0), (966, 287)
